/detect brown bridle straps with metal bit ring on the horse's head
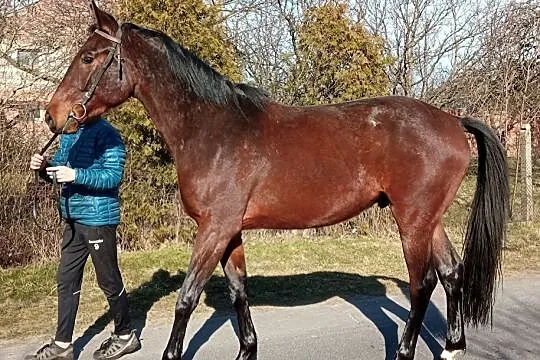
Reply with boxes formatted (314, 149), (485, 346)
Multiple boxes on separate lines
(67, 25), (124, 132)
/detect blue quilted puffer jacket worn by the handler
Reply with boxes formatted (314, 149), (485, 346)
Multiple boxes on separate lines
(44, 119), (126, 226)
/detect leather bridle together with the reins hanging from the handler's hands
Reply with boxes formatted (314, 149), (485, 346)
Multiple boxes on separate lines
(32, 25), (123, 231)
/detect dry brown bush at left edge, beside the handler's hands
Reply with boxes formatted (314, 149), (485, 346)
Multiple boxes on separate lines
(0, 119), (60, 268)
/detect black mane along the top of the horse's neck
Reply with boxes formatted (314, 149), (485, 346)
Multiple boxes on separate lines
(125, 24), (269, 110)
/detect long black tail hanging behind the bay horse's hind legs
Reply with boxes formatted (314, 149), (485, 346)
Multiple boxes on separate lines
(461, 118), (510, 326)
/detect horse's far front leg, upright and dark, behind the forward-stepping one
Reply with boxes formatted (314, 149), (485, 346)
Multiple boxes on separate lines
(221, 233), (257, 360)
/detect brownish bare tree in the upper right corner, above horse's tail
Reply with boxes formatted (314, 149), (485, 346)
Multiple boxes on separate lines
(432, 1), (540, 158)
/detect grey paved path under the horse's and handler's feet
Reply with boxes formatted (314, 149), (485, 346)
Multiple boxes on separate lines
(0, 274), (540, 360)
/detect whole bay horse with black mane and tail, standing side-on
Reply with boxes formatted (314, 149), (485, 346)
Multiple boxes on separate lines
(46, 0), (509, 360)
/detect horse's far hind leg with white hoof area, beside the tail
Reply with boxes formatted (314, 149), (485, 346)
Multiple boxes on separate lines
(433, 223), (466, 360)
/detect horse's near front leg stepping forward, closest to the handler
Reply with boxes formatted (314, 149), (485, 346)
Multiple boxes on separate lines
(162, 221), (240, 360)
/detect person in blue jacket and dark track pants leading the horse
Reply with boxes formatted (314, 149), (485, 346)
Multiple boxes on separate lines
(25, 119), (140, 360)
